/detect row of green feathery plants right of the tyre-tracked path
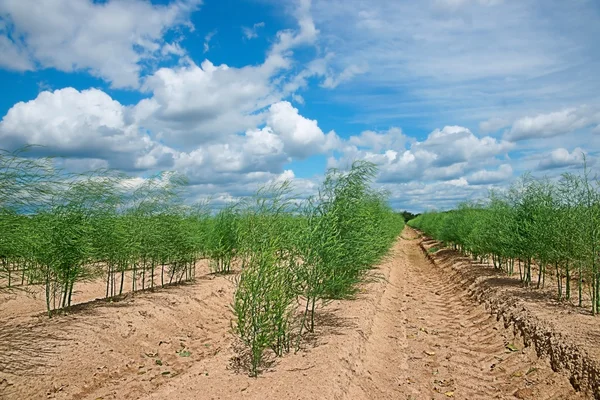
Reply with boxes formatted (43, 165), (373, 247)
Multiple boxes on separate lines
(409, 168), (600, 314)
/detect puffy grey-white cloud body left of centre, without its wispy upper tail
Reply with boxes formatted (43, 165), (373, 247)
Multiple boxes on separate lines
(135, 60), (284, 145)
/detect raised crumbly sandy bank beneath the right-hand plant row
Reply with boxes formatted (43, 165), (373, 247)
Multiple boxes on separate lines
(422, 231), (600, 399)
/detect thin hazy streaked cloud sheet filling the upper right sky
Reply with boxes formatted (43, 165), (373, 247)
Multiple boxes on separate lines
(312, 0), (600, 127)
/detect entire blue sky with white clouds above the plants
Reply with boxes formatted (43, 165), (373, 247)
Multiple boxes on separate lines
(0, 0), (600, 212)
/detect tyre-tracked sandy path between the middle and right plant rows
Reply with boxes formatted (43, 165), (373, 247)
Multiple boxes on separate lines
(338, 229), (583, 399)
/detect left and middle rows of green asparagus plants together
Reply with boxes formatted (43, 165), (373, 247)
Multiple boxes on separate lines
(0, 151), (404, 376)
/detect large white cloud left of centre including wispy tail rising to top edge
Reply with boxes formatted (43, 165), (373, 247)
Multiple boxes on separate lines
(134, 0), (324, 145)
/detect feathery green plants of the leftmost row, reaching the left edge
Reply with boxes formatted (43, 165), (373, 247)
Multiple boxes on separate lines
(0, 149), (206, 314)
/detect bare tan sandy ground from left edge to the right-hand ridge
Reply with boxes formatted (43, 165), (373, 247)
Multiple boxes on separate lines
(0, 228), (584, 400)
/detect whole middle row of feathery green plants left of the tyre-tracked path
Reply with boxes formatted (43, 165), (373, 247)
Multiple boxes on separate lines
(233, 162), (403, 376)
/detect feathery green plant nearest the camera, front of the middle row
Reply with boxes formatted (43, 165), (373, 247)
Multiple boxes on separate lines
(233, 183), (296, 376)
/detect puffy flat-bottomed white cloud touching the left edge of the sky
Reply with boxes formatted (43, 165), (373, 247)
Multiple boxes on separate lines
(0, 88), (174, 169)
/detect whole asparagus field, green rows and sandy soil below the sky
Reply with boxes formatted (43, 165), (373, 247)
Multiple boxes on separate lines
(0, 148), (600, 400)
